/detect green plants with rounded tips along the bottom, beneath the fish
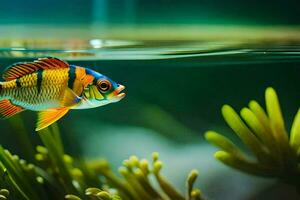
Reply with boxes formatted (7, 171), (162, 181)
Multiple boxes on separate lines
(0, 120), (203, 200)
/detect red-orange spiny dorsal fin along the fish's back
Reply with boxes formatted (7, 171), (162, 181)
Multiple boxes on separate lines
(3, 57), (69, 81)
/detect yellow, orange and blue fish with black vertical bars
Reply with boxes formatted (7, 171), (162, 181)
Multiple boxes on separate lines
(0, 57), (125, 131)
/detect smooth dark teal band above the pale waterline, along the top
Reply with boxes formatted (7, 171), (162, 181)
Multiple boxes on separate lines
(0, 0), (300, 25)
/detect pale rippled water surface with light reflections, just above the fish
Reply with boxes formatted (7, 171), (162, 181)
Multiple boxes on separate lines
(0, 39), (300, 62)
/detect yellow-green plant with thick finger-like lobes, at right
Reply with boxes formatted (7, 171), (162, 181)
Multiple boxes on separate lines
(205, 88), (300, 187)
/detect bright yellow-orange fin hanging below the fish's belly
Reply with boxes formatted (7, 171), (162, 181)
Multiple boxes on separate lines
(35, 107), (70, 131)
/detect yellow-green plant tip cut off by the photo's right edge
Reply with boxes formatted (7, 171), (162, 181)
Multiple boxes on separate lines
(290, 109), (300, 153)
